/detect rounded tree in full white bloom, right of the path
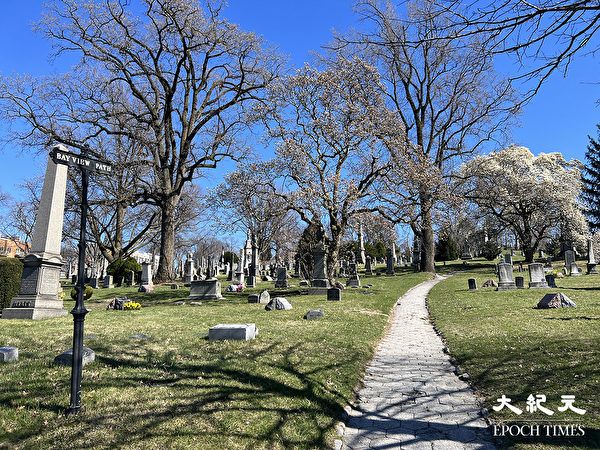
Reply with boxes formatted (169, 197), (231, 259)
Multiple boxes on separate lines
(461, 146), (587, 262)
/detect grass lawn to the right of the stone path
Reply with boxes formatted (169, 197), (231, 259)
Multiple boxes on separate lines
(428, 262), (600, 449)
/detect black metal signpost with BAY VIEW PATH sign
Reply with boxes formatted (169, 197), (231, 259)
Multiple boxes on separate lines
(50, 147), (112, 416)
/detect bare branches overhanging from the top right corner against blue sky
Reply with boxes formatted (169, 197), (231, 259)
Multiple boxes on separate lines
(428, 0), (600, 98)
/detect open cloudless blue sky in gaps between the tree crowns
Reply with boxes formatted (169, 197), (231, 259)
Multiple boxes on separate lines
(0, 0), (600, 200)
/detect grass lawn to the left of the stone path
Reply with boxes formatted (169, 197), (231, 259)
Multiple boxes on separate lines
(0, 272), (432, 449)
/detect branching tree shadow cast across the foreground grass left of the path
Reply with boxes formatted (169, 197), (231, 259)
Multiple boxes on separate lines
(0, 344), (353, 448)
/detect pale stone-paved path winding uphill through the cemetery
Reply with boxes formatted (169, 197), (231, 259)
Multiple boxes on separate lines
(336, 276), (496, 450)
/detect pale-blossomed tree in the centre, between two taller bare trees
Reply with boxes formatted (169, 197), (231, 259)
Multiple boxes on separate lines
(258, 57), (405, 276)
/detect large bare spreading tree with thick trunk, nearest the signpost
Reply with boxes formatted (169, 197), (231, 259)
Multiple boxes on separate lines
(0, 0), (280, 281)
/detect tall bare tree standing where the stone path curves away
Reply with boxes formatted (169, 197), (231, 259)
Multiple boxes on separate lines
(337, 0), (516, 272)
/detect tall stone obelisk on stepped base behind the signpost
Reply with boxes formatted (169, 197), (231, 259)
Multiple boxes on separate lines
(2, 145), (68, 319)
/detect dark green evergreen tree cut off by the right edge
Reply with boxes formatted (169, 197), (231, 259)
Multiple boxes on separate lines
(581, 124), (600, 231)
